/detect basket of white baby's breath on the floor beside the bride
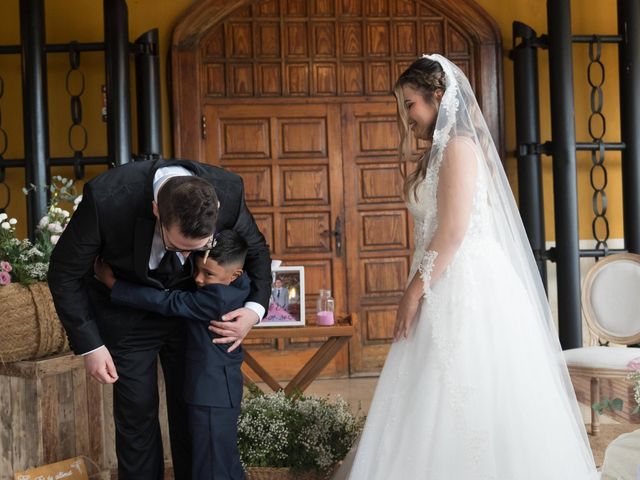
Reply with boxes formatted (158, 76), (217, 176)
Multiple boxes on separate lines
(238, 389), (364, 480)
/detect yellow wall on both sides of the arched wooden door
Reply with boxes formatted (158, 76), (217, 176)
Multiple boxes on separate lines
(0, 0), (623, 240)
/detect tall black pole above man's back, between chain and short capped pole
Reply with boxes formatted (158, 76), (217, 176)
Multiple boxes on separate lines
(103, 0), (131, 165)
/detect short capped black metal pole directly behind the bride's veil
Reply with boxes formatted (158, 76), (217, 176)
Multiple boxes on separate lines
(512, 22), (547, 289)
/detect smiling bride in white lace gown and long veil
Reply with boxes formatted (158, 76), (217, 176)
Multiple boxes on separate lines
(336, 55), (597, 480)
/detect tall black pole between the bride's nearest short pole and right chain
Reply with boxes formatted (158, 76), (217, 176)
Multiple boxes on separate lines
(547, 0), (582, 349)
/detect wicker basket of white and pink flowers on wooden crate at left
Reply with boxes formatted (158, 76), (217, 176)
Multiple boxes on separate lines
(0, 176), (80, 362)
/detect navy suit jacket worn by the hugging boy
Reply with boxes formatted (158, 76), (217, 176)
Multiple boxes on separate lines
(111, 274), (249, 408)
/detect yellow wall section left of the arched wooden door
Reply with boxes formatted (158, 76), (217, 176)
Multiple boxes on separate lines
(0, 0), (192, 236)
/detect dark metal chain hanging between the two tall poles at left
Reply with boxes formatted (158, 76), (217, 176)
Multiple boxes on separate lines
(65, 42), (88, 179)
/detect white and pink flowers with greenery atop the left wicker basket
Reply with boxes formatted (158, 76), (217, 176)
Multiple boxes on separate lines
(0, 176), (80, 285)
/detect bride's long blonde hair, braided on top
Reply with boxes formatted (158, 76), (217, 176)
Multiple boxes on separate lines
(393, 57), (446, 198)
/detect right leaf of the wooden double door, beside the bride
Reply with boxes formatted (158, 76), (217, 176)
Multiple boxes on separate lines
(342, 102), (412, 373)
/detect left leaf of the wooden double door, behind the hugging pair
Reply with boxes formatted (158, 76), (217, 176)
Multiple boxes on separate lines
(204, 104), (348, 378)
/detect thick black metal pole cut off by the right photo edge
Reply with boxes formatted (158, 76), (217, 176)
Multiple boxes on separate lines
(618, 0), (640, 253)
